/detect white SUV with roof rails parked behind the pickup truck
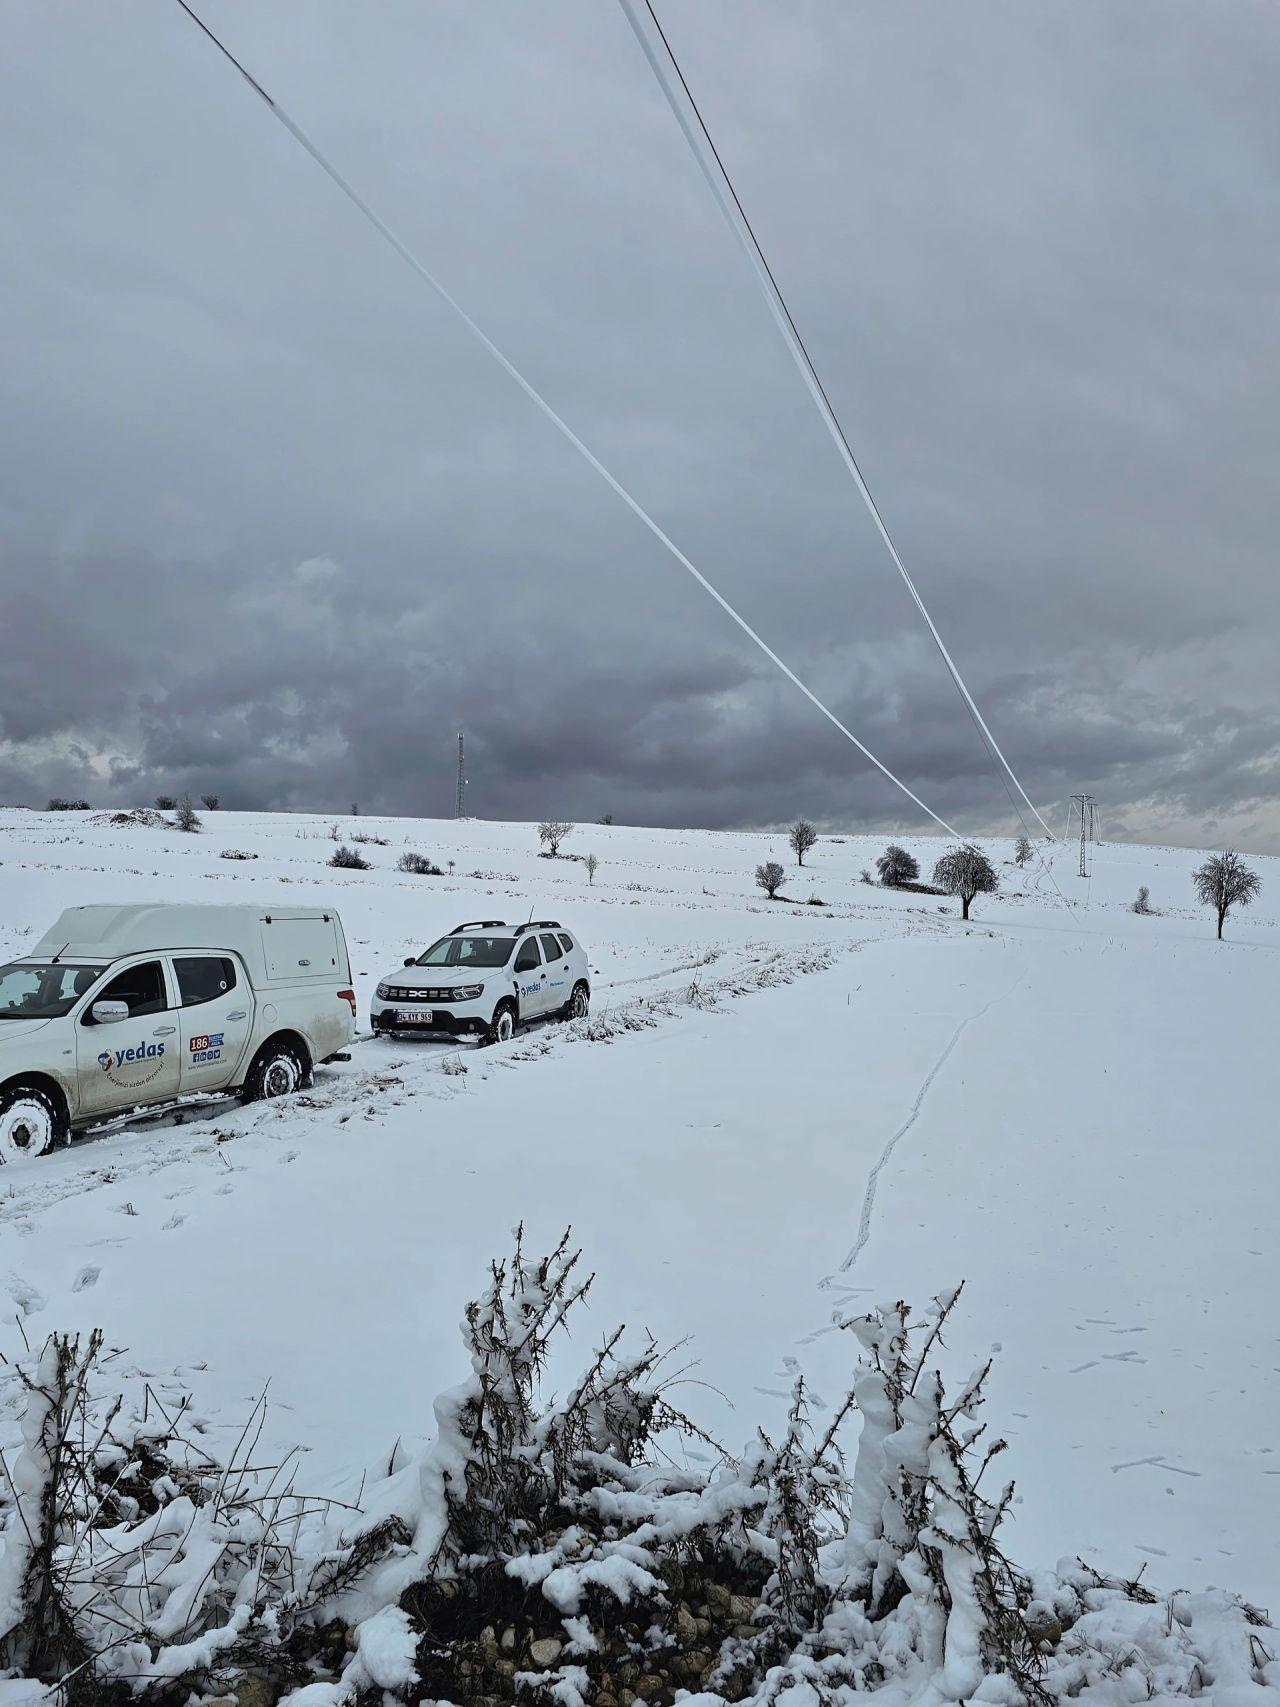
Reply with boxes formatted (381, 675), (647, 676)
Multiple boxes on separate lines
(369, 918), (591, 1043)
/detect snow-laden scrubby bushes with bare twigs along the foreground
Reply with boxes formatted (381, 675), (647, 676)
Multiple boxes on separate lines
(0, 1231), (1280, 1707)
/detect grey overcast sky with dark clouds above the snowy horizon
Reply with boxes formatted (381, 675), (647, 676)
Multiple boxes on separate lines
(0, 0), (1280, 850)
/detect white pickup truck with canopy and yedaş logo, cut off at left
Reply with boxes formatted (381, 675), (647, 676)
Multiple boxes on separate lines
(0, 906), (355, 1161)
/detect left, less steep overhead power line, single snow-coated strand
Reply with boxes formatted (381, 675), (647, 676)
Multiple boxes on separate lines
(168, 0), (963, 840)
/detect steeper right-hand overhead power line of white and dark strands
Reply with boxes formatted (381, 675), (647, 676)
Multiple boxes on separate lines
(620, 0), (1053, 838)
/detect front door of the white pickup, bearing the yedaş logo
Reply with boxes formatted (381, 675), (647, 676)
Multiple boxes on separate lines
(75, 959), (177, 1121)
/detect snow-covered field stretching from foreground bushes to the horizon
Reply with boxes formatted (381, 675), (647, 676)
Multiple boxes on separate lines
(0, 811), (1280, 1611)
